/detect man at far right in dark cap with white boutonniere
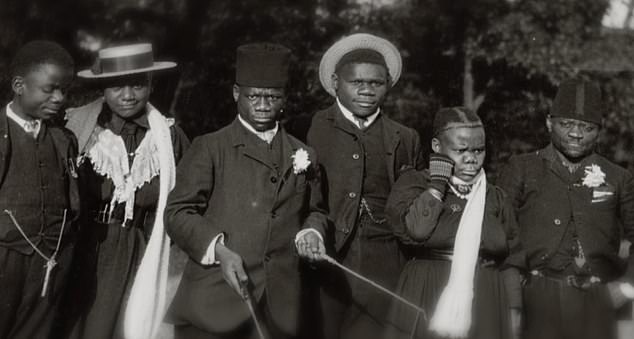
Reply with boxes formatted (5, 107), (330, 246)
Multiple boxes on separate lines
(498, 80), (634, 339)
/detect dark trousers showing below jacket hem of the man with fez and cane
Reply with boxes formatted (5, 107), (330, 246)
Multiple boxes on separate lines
(174, 293), (294, 339)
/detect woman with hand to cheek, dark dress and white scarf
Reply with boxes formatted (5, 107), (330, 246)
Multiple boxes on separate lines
(386, 107), (525, 339)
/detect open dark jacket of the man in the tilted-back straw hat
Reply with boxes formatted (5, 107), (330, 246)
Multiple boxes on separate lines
(308, 103), (423, 250)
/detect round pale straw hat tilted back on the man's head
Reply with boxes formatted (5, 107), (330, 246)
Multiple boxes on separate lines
(319, 33), (403, 97)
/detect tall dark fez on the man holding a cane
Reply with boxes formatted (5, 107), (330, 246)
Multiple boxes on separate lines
(236, 43), (291, 88)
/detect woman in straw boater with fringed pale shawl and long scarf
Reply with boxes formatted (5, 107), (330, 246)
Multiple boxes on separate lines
(61, 43), (189, 339)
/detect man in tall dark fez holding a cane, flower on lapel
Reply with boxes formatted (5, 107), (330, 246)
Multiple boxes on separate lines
(165, 43), (326, 339)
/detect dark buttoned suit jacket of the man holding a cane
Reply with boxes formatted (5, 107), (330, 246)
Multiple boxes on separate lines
(165, 119), (326, 334)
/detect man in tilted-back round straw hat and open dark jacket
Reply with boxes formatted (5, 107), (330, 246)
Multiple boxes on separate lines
(307, 33), (422, 339)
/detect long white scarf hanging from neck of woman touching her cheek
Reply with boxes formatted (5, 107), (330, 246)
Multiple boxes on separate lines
(429, 170), (487, 338)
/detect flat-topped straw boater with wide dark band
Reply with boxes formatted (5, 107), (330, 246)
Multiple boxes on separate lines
(77, 43), (176, 79)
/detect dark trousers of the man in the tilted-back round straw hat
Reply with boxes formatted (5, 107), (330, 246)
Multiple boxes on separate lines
(319, 223), (403, 339)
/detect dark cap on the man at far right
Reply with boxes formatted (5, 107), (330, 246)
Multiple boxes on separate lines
(550, 79), (603, 125)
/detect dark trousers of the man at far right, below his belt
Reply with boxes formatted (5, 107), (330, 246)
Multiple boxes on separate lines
(524, 276), (616, 339)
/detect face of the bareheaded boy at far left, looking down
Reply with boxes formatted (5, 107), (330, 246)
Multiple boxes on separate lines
(11, 64), (73, 120)
